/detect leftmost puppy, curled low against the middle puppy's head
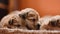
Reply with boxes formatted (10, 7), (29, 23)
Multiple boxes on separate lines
(1, 11), (26, 29)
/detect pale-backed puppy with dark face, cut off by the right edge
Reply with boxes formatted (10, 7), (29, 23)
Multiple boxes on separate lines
(41, 15), (60, 30)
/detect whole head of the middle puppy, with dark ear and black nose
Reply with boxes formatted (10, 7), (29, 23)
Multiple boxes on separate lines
(20, 8), (40, 30)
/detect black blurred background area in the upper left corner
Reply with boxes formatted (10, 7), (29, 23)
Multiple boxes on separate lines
(0, 0), (9, 20)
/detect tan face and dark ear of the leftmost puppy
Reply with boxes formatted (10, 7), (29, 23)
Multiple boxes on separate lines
(3, 17), (21, 28)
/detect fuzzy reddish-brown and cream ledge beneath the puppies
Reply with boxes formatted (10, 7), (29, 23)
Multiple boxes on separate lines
(0, 28), (60, 34)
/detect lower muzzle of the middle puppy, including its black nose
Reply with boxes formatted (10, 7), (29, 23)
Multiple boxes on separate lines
(26, 20), (40, 30)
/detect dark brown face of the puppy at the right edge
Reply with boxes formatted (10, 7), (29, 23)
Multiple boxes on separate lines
(46, 19), (60, 30)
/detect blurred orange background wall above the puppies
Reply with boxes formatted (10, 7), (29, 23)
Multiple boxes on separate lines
(0, 0), (60, 17)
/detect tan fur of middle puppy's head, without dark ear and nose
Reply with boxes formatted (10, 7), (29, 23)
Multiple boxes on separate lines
(21, 8), (40, 30)
